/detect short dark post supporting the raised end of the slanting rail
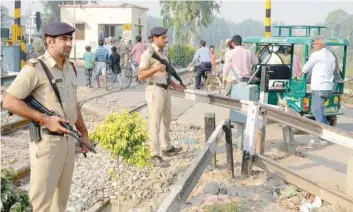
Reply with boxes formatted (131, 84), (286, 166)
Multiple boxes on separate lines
(223, 119), (235, 178)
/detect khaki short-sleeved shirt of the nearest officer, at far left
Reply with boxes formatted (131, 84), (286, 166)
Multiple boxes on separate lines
(7, 51), (77, 125)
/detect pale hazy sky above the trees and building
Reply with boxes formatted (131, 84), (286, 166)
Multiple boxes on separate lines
(0, 0), (353, 25)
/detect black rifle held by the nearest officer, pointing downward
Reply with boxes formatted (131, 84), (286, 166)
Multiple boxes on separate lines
(23, 96), (97, 157)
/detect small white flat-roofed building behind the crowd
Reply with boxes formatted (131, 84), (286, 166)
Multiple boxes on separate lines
(60, 4), (148, 58)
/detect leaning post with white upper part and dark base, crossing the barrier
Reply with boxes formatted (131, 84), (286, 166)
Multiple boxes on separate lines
(241, 102), (260, 177)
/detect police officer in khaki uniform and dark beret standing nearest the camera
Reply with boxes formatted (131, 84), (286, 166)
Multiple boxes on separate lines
(3, 22), (90, 212)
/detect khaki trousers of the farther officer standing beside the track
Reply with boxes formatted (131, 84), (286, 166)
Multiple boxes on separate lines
(146, 85), (172, 156)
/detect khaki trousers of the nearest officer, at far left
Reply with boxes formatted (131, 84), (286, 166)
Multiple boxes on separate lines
(29, 134), (75, 212)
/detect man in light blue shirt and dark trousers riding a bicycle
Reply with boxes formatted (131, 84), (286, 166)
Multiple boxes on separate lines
(190, 40), (212, 89)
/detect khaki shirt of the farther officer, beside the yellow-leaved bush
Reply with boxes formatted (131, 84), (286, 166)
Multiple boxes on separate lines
(139, 44), (168, 85)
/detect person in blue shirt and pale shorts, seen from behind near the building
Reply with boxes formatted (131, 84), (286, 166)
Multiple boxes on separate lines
(93, 40), (109, 90)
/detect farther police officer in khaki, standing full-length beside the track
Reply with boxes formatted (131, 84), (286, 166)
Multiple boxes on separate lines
(138, 27), (184, 167)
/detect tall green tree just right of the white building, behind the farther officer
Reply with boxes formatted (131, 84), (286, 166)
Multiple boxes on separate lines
(160, 0), (220, 44)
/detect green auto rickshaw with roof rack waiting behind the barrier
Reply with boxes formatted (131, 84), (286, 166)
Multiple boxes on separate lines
(236, 26), (349, 126)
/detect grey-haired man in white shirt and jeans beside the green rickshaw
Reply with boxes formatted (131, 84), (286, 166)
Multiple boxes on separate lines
(302, 37), (336, 145)
